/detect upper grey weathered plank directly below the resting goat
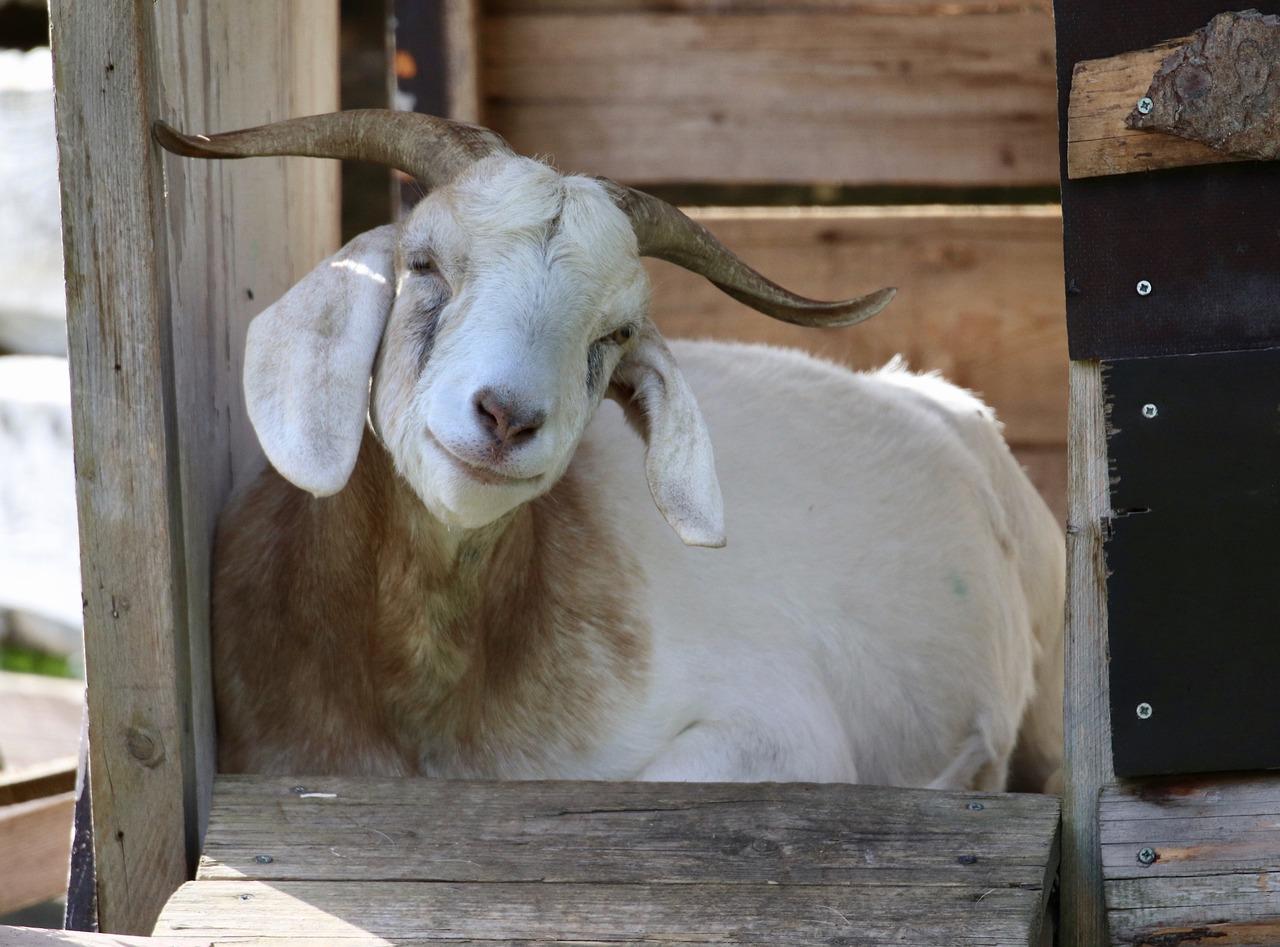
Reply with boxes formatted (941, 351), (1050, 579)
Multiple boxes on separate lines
(197, 777), (1057, 887)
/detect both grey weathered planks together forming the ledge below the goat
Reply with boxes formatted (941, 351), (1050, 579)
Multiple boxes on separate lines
(156, 777), (1057, 947)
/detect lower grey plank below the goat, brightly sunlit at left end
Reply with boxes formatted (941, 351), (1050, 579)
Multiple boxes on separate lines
(156, 882), (1039, 947)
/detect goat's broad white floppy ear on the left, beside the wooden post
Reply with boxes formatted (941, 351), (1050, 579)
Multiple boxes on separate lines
(244, 225), (397, 497)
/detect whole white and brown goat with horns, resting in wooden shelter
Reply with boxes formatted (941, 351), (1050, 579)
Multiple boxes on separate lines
(156, 111), (1064, 790)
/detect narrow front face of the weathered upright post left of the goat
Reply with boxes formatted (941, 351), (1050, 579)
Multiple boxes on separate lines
(50, 0), (195, 932)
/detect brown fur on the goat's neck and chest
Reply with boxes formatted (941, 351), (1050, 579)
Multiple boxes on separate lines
(214, 433), (648, 777)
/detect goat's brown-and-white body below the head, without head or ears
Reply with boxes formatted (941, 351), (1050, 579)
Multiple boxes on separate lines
(214, 343), (1064, 790)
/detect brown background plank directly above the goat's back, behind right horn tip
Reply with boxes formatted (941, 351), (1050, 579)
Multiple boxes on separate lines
(649, 206), (1066, 447)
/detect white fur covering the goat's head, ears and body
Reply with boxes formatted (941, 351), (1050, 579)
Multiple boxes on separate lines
(238, 156), (1064, 788)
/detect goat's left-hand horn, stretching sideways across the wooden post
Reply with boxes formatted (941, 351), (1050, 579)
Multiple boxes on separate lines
(152, 109), (509, 189)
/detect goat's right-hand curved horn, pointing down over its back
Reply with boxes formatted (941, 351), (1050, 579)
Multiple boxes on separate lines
(605, 182), (897, 326)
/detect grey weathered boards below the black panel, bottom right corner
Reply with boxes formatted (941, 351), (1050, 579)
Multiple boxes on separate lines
(1098, 774), (1280, 944)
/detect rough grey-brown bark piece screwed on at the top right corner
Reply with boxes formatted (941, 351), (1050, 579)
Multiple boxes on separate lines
(1125, 10), (1280, 160)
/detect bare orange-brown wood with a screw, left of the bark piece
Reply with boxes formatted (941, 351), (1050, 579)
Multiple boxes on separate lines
(1066, 37), (1242, 180)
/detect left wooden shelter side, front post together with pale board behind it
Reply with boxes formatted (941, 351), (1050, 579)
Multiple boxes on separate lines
(51, 0), (338, 933)
